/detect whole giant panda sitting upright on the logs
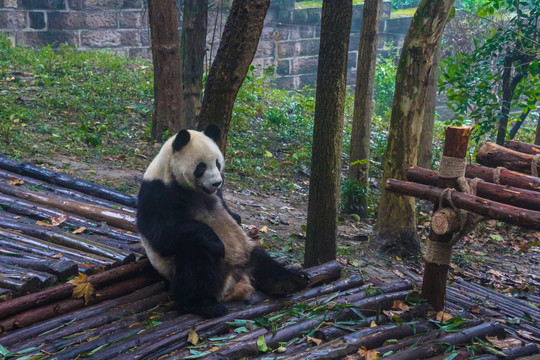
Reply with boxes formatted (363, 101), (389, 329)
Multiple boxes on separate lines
(137, 125), (308, 318)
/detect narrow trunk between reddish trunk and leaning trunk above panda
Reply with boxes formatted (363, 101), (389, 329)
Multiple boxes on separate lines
(181, 0), (208, 129)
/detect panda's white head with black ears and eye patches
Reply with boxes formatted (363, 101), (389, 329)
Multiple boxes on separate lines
(169, 125), (224, 194)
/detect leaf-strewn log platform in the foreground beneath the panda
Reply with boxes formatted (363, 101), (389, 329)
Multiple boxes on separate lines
(0, 262), (540, 360)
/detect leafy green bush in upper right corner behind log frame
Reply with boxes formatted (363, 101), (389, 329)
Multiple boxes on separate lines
(439, 0), (540, 141)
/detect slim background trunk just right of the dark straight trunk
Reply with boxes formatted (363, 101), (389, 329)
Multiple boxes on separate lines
(344, 0), (382, 218)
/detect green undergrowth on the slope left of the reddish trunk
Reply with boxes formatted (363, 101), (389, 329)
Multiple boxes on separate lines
(0, 36), (153, 162)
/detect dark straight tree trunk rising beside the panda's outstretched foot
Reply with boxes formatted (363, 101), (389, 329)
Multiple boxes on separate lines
(305, 0), (352, 267)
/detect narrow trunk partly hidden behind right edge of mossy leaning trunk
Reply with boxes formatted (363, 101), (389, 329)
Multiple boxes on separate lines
(418, 45), (441, 169)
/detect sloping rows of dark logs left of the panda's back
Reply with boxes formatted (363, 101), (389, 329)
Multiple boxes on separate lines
(0, 157), (141, 301)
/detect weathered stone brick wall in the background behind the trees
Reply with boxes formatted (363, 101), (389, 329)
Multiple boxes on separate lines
(0, 0), (408, 89)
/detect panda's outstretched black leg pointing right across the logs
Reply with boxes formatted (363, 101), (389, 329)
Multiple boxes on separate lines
(250, 246), (309, 296)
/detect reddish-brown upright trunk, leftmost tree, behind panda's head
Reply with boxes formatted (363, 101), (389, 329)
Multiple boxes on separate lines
(148, 0), (185, 141)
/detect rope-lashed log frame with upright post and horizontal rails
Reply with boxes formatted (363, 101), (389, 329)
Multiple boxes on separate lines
(386, 127), (540, 310)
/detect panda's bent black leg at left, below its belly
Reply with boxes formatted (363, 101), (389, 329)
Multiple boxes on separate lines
(171, 248), (228, 318)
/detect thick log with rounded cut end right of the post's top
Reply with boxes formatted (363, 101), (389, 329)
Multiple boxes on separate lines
(476, 142), (534, 174)
